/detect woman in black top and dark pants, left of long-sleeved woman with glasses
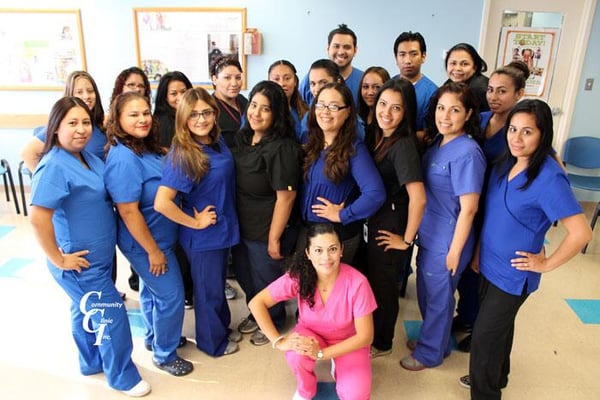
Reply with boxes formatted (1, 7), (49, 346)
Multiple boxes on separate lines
(232, 81), (301, 346)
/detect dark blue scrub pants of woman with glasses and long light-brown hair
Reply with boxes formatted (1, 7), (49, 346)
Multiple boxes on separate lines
(184, 247), (231, 357)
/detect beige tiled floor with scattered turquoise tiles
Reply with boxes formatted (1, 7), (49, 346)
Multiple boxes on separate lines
(0, 199), (600, 400)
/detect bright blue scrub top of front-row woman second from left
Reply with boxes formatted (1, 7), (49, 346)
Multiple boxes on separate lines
(104, 142), (178, 253)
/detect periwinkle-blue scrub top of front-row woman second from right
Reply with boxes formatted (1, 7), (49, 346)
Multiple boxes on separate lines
(419, 135), (486, 253)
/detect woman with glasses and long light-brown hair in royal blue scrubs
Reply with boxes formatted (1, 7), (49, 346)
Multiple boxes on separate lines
(154, 88), (241, 357)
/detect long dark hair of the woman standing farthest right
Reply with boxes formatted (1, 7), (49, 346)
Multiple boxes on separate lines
(496, 99), (554, 190)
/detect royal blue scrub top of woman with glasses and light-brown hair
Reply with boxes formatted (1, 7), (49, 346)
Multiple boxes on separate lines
(160, 137), (240, 251)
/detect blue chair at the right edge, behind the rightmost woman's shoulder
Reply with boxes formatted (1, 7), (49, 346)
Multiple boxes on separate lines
(563, 136), (600, 254)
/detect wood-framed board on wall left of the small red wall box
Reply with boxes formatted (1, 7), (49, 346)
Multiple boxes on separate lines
(133, 8), (246, 89)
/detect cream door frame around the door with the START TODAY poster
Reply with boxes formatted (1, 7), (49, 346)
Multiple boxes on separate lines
(479, 0), (598, 154)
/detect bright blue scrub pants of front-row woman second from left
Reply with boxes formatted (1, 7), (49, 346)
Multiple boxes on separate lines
(123, 250), (185, 364)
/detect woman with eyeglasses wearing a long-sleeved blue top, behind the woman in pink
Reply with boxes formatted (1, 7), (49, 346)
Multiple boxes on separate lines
(296, 82), (385, 263)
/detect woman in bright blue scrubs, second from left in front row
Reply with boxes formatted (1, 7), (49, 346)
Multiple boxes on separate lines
(104, 92), (194, 376)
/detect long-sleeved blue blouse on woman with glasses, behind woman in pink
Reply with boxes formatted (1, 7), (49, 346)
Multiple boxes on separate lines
(300, 141), (386, 225)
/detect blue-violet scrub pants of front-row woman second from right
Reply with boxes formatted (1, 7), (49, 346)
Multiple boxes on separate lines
(412, 248), (471, 368)
